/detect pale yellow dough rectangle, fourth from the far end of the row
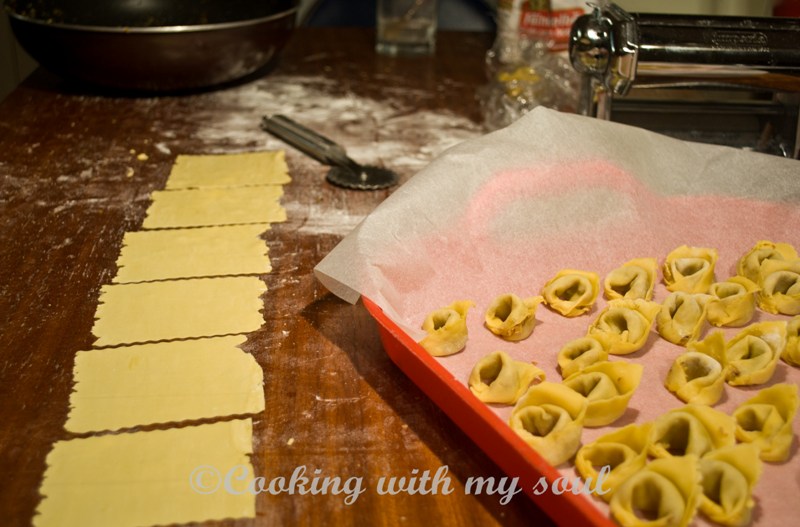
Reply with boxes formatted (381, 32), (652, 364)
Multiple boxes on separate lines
(92, 276), (267, 346)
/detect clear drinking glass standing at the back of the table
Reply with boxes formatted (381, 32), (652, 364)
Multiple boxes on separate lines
(375, 0), (436, 56)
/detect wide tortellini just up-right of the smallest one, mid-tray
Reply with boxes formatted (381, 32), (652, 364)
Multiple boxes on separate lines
(588, 299), (661, 355)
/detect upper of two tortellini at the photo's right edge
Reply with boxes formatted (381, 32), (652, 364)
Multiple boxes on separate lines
(758, 259), (800, 315)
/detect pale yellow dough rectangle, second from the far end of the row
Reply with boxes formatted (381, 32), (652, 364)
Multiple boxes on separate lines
(142, 185), (286, 229)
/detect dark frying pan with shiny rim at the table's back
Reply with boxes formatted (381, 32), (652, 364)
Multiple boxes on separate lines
(5, 0), (297, 91)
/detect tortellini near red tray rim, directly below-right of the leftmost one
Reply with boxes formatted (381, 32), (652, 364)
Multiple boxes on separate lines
(468, 351), (545, 404)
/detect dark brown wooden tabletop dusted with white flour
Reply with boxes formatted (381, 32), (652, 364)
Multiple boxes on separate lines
(0, 29), (550, 526)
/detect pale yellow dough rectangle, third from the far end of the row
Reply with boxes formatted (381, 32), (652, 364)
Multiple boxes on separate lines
(113, 224), (272, 283)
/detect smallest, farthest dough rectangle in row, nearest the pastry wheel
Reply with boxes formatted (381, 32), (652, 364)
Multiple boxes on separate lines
(166, 150), (291, 190)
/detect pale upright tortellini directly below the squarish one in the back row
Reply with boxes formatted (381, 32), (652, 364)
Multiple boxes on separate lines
(656, 291), (711, 346)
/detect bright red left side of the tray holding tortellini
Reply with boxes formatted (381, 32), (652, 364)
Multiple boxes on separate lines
(362, 297), (616, 527)
